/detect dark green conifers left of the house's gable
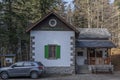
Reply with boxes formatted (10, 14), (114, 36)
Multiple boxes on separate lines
(0, 0), (57, 59)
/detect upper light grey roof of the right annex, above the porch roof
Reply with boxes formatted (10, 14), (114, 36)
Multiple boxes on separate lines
(78, 28), (111, 39)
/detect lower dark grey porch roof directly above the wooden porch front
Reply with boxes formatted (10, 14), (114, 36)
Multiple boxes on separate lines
(76, 40), (115, 48)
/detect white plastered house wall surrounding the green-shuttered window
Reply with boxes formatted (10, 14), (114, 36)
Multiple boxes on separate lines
(30, 31), (75, 67)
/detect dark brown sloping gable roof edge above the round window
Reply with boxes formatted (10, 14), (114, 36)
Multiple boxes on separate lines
(26, 12), (79, 33)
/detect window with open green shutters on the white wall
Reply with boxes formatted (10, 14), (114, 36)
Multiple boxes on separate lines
(45, 45), (60, 59)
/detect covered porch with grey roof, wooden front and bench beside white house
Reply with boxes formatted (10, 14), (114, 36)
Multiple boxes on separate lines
(76, 40), (114, 73)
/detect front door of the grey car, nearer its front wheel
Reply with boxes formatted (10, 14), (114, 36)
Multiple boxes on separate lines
(8, 62), (24, 77)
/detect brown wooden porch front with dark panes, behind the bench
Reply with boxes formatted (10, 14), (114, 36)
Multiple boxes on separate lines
(87, 48), (111, 65)
